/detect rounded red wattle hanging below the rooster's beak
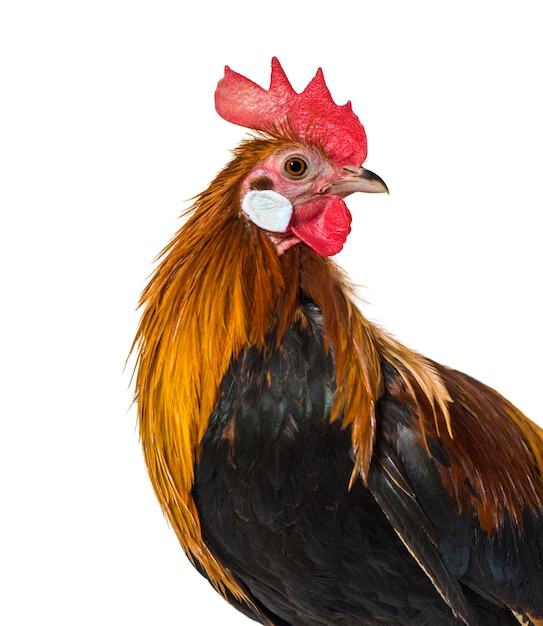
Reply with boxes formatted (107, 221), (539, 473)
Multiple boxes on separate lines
(290, 195), (352, 257)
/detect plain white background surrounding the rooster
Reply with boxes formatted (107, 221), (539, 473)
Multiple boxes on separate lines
(0, 0), (543, 626)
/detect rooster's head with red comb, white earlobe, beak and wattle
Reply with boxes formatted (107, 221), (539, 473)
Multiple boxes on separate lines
(215, 58), (388, 257)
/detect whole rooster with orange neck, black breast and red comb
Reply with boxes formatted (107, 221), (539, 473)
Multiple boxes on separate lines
(134, 58), (543, 626)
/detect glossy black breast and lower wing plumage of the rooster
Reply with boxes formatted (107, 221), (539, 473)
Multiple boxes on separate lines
(193, 303), (543, 626)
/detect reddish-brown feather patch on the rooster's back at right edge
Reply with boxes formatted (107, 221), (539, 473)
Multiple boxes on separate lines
(426, 364), (543, 532)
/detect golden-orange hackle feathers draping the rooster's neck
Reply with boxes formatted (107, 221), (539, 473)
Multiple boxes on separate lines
(134, 135), (472, 601)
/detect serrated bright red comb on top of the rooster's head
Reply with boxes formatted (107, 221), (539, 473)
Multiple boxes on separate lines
(215, 57), (367, 166)
